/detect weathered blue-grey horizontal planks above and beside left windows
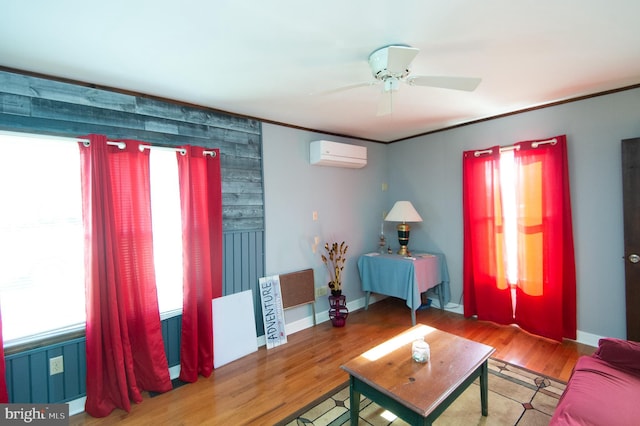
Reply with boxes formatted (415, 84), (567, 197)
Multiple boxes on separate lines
(0, 71), (264, 231)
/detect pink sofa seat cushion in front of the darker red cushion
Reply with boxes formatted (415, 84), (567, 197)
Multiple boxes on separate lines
(550, 356), (640, 426)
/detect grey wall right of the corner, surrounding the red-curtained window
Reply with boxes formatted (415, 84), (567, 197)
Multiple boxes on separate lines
(388, 89), (640, 344)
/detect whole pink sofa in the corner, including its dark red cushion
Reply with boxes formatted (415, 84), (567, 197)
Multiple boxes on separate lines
(550, 338), (640, 426)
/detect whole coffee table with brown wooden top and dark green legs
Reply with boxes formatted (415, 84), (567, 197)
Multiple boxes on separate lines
(342, 324), (495, 426)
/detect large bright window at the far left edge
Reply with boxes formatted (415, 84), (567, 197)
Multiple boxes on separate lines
(0, 135), (85, 344)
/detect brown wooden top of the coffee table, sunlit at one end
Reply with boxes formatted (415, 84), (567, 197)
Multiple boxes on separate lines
(342, 324), (494, 417)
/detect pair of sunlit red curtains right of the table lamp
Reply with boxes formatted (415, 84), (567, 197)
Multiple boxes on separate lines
(463, 136), (576, 341)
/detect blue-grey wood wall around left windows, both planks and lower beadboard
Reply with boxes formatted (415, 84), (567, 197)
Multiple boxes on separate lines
(0, 69), (265, 403)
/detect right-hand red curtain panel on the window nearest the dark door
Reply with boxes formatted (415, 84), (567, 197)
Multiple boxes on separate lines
(514, 135), (577, 341)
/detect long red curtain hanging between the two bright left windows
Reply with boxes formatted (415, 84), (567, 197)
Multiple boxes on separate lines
(80, 135), (171, 417)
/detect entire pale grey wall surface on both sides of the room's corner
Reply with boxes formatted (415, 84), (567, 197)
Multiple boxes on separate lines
(263, 89), (640, 345)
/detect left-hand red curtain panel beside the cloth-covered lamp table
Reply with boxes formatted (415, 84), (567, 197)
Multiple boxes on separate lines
(462, 146), (513, 324)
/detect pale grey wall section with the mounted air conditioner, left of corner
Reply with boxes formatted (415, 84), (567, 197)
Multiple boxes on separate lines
(262, 124), (390, 327)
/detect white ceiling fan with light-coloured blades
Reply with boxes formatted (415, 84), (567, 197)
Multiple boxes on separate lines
(328, 45), (481, 115)
